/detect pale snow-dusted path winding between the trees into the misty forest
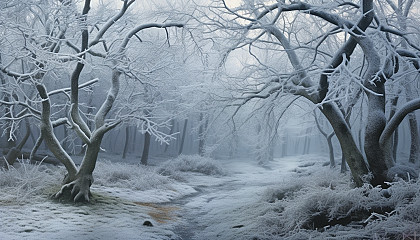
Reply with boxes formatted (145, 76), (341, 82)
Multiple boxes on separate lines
(167, 160), (297, 240)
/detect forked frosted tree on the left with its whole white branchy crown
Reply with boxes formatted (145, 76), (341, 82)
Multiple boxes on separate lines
(0, 0), (184, 201)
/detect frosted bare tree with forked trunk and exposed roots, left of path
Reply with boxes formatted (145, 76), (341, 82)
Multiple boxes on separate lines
(0, 0), (184, 201)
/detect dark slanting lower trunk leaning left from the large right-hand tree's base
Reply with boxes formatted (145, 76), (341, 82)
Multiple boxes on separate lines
(321, 103), (369, 187)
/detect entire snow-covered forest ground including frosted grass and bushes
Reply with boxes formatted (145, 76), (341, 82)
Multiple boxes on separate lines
(0, 155), (420, 240)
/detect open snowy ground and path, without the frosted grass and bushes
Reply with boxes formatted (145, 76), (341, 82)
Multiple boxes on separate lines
(0, 153), (297, 240)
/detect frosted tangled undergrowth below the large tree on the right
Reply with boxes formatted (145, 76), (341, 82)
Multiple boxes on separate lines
(258, 168), (420, 239)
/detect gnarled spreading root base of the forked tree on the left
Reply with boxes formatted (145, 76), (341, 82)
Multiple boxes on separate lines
(53, 174), (93, 202)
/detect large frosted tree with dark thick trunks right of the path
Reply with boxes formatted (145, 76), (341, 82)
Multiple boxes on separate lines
(197, 0), (420, 186)
